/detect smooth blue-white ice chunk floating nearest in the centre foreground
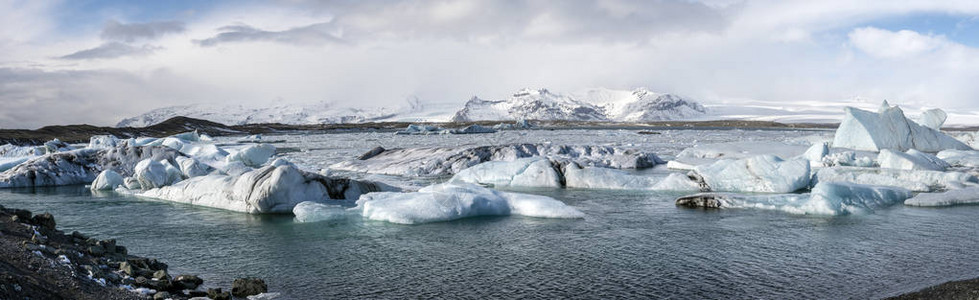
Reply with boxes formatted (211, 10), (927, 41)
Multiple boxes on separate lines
(357, 183), (584, 224)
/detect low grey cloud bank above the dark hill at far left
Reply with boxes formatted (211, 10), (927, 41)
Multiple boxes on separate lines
(0, 68), (215, 129)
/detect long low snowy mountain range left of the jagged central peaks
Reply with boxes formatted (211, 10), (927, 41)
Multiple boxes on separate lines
(116, 97), (457, 127)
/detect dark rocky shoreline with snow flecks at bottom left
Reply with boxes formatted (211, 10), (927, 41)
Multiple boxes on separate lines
(0, 206), (268, 299)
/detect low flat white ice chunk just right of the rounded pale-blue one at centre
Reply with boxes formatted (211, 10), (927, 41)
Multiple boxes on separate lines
(560, 164), (658, 190)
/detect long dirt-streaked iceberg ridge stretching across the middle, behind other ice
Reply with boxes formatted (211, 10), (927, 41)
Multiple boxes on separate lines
(330, 144), (665, 176)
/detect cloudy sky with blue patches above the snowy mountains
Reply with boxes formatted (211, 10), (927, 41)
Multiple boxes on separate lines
(0, 0), (979, 128)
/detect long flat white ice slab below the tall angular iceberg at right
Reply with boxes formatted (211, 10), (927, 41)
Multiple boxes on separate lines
(813, 167), (979, 192)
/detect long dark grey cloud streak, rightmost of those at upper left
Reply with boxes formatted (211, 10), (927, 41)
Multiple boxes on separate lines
(196, 22), (343, 47)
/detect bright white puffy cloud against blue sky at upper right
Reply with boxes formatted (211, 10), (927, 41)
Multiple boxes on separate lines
(848, 27), (950, 59)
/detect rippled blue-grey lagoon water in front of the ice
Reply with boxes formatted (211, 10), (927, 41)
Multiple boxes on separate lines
(0, 186), (979, 299)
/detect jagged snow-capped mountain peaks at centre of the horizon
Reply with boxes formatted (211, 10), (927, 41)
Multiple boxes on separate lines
(452, 88), (706, 122)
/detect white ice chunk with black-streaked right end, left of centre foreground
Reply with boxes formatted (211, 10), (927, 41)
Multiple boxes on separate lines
(138, 165), (397, 214)
